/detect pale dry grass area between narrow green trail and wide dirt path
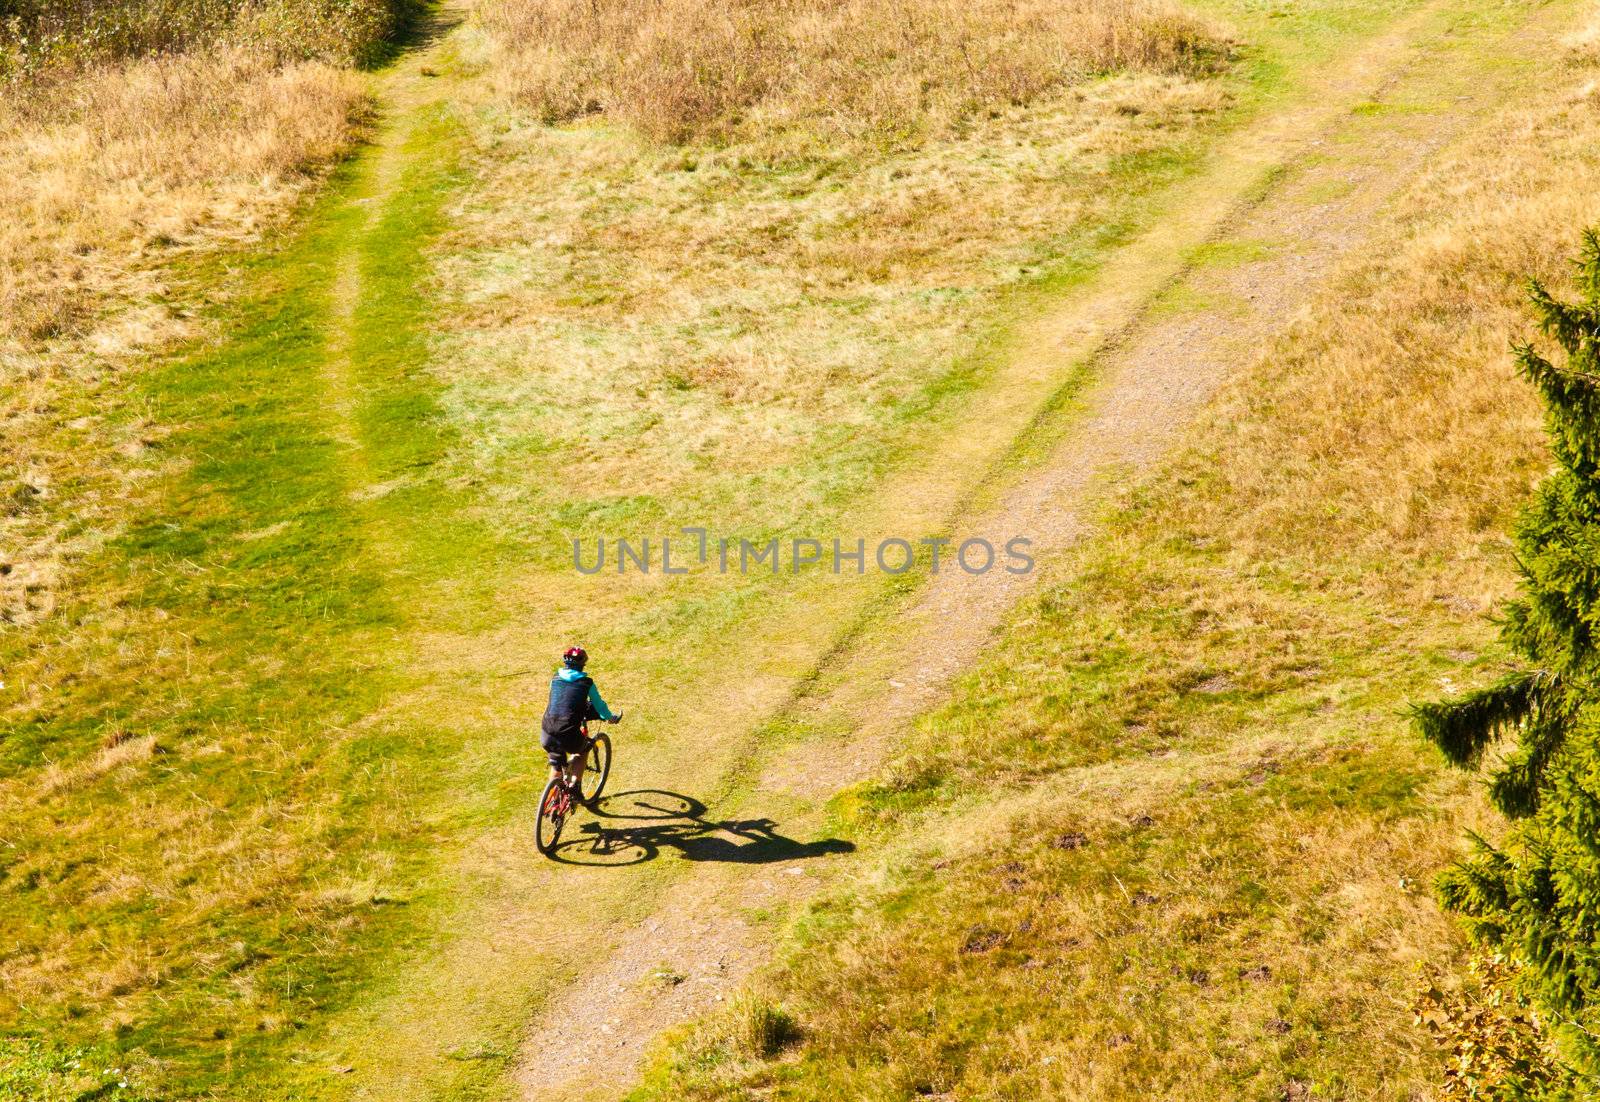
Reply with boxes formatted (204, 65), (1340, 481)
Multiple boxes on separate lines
(442, 0), (1227, 526)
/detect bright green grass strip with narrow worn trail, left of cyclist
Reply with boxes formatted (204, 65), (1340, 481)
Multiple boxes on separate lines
(0, 10), (478, 1097)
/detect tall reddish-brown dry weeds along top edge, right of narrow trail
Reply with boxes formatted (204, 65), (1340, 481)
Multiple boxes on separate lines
(480, 0), (1222, 142)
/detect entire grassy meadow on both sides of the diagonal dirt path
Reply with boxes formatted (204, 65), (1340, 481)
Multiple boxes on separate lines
(0, 0), (1592, 1102)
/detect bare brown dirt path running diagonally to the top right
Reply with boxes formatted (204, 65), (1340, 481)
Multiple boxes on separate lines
(502, 5), (1574, 1099)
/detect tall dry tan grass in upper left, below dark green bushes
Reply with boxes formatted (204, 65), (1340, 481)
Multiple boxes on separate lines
(0, 50), (360, 342)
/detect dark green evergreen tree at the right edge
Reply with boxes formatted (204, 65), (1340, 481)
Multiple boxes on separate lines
(1414, 230), (1600, 1089)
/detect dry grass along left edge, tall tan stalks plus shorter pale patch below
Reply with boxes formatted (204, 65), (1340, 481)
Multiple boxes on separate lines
(0, 48), (365, 624)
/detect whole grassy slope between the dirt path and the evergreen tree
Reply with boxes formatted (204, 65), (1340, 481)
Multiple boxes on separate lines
(635, 6), (1600, 1099)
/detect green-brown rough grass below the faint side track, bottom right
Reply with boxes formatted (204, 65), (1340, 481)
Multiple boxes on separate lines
(634, 745), (1465, 1099)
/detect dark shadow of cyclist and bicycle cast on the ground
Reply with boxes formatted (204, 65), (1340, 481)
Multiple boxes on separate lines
(550, 789), (856, 865)
